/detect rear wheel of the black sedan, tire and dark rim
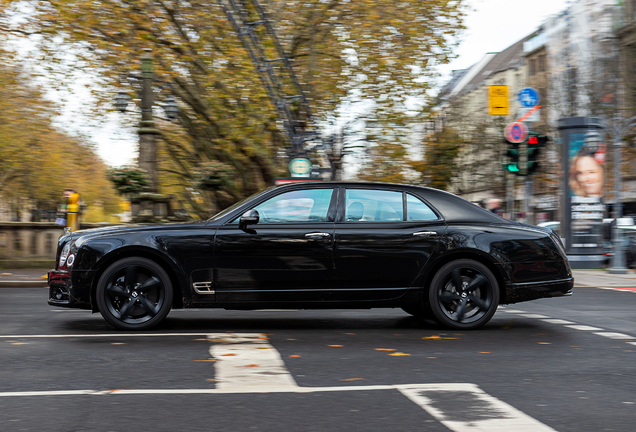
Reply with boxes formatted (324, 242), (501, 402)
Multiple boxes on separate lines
(428, 259), (499, 330)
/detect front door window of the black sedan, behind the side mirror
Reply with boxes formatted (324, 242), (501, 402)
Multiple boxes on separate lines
(255, 189), (333, 224)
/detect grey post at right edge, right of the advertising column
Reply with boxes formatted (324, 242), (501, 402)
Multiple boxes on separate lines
(603, 114), (636, 274)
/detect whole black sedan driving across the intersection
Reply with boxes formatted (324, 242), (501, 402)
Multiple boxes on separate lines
(48, 182), (574, 330)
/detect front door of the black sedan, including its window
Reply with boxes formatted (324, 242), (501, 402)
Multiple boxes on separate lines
(214, 187), (337, 302)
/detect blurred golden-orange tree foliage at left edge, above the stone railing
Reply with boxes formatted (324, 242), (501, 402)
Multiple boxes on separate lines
(0, 50), (120, 218)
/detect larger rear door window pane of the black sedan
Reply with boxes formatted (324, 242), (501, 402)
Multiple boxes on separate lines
(345, 189), (404, 222)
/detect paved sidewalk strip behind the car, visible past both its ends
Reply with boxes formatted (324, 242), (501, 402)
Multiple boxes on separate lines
(0, 269), (636, 288)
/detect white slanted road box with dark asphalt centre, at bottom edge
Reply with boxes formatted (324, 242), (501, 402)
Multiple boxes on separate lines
(400, 384), (554, 432)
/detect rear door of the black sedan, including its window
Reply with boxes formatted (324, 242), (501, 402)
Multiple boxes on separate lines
(334, 188), (446, 301)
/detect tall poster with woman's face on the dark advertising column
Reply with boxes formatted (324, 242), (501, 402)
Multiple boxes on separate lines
(569, 133), (605, 246)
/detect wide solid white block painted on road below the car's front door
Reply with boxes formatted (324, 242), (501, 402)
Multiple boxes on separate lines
(208, 333), (298, 392)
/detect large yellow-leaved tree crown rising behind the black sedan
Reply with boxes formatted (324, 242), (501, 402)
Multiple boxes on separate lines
(0, 0), (464, 216)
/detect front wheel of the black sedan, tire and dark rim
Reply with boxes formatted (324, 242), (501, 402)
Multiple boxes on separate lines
(96, 257), (172, 330)
